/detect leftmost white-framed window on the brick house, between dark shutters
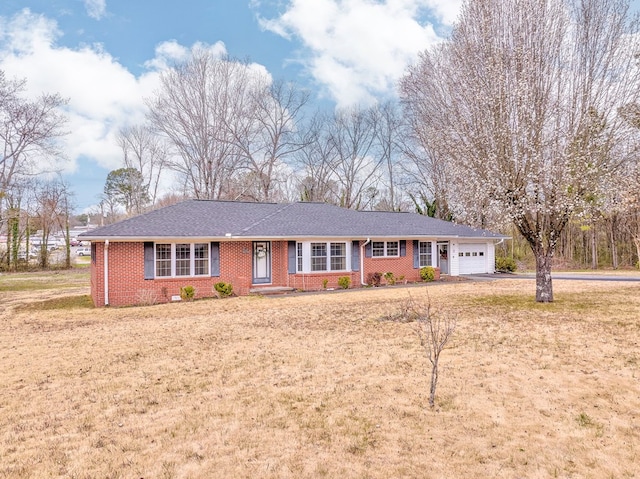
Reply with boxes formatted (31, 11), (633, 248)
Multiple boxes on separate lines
(155, 243), (210, 278)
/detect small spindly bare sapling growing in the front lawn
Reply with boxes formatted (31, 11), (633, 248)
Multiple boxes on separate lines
(402, 296), (457, 408)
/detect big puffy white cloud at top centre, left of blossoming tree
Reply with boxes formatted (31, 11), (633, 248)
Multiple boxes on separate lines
(261, 0), (461, 106)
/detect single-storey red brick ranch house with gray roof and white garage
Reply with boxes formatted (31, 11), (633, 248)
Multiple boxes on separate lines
(80, 200), (505, 306)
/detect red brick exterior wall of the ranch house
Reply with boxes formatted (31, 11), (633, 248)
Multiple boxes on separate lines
(91, 241), (450, 307)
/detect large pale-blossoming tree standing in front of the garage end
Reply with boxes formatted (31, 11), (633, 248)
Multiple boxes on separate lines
(401, 0), (640, 302)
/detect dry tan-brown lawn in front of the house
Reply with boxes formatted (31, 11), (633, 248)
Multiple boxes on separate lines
(0, 274), (640, 478)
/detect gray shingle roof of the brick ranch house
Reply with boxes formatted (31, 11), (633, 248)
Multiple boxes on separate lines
(81, 200), (505, 240)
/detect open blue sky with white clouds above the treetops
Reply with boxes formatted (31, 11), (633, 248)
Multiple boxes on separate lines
(0, 0), (462, 211)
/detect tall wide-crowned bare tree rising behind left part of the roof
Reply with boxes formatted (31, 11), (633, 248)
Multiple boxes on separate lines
(147, 50), (249, 199)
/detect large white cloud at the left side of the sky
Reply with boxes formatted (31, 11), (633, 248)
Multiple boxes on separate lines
(0, 9), (232, 178)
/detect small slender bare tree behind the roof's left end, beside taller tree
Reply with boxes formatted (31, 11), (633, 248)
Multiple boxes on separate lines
(117, 126), (169, 205)
